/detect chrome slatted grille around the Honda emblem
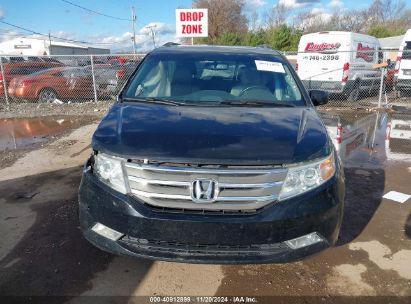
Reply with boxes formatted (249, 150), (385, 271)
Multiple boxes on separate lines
(125, 162), (287, 211)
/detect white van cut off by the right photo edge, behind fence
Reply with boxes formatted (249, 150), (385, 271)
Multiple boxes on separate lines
(394, 29), (411, 96)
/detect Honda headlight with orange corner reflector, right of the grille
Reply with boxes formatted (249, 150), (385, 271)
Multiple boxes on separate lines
(279, 154), (335, 200)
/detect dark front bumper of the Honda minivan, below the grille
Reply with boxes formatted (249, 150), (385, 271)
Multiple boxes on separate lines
(79, 166), (344, 264)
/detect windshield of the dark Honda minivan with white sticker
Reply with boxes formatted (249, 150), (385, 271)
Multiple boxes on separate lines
(123, 53), (306, 106)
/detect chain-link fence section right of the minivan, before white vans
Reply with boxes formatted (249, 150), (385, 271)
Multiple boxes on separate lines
(284, 49), (411, 108)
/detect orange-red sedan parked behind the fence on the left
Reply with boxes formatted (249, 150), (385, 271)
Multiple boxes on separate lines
(8, 67), (94, 102)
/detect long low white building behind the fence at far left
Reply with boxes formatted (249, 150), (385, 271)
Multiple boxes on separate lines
(0, 37), (110, 56)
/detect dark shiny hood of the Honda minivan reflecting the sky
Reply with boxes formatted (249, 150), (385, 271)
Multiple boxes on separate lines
(92, 103), (331, 165)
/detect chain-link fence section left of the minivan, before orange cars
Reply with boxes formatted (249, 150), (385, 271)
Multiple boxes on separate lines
(0, 54), (144, 104)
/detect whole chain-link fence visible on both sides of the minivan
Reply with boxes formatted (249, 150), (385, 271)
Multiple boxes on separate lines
(0, 50), (411, 108)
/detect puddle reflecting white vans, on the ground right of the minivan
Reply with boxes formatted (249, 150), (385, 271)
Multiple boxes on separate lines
(320, 111), (411, 169)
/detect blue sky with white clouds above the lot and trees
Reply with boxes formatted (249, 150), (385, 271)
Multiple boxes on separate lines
(0, 0), (406, 51)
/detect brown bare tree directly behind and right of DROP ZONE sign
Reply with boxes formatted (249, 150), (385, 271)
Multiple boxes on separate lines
(194, 0), (248, 43)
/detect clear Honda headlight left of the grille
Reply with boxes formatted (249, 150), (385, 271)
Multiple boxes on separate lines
(94, 153), (127, 194)
